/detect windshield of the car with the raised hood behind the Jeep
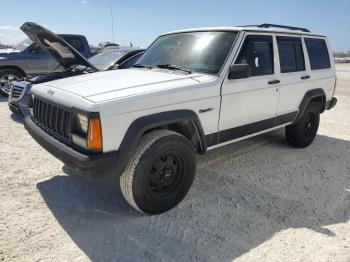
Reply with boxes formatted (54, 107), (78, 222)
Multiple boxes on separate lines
(89, 49), (130, 71)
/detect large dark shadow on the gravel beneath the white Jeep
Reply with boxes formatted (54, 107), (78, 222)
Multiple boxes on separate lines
(37, 131), (350, 261)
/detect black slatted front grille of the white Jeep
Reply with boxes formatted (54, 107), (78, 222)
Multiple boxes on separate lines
(33, 97), (71, 139)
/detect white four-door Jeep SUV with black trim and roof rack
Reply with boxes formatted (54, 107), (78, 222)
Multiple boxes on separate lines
(25, 24), (337, 214)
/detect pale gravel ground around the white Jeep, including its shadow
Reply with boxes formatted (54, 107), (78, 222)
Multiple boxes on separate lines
(0, 65), (350, 262)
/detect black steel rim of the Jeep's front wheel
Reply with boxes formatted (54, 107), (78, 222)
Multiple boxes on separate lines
(148, 151), (184, 198)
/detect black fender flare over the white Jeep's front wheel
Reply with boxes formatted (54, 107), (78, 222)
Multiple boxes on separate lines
(118, 110), (207, 175)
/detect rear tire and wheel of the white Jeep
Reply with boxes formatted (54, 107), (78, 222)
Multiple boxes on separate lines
(286, 102), (320, 148)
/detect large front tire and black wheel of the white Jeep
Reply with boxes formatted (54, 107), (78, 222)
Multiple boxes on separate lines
(120, 130), (196, 215)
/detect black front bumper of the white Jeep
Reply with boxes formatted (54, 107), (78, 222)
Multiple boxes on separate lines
(24, 116), (121, 180)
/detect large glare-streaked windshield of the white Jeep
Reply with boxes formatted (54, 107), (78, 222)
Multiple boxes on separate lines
(137, 32), (237, 75)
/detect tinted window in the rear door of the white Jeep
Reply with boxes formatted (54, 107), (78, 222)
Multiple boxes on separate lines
(277, 36), (305, 73)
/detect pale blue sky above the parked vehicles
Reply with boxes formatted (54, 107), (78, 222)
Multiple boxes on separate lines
(0, 0), (350, 51)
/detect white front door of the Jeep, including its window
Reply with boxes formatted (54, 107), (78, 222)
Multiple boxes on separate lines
(219, 32), (279, 143)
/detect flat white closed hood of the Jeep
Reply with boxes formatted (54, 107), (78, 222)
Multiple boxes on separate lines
(34, 68), (216, 103)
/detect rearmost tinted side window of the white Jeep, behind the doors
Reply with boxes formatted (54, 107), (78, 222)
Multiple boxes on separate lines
(305, 38), (331, 70)
